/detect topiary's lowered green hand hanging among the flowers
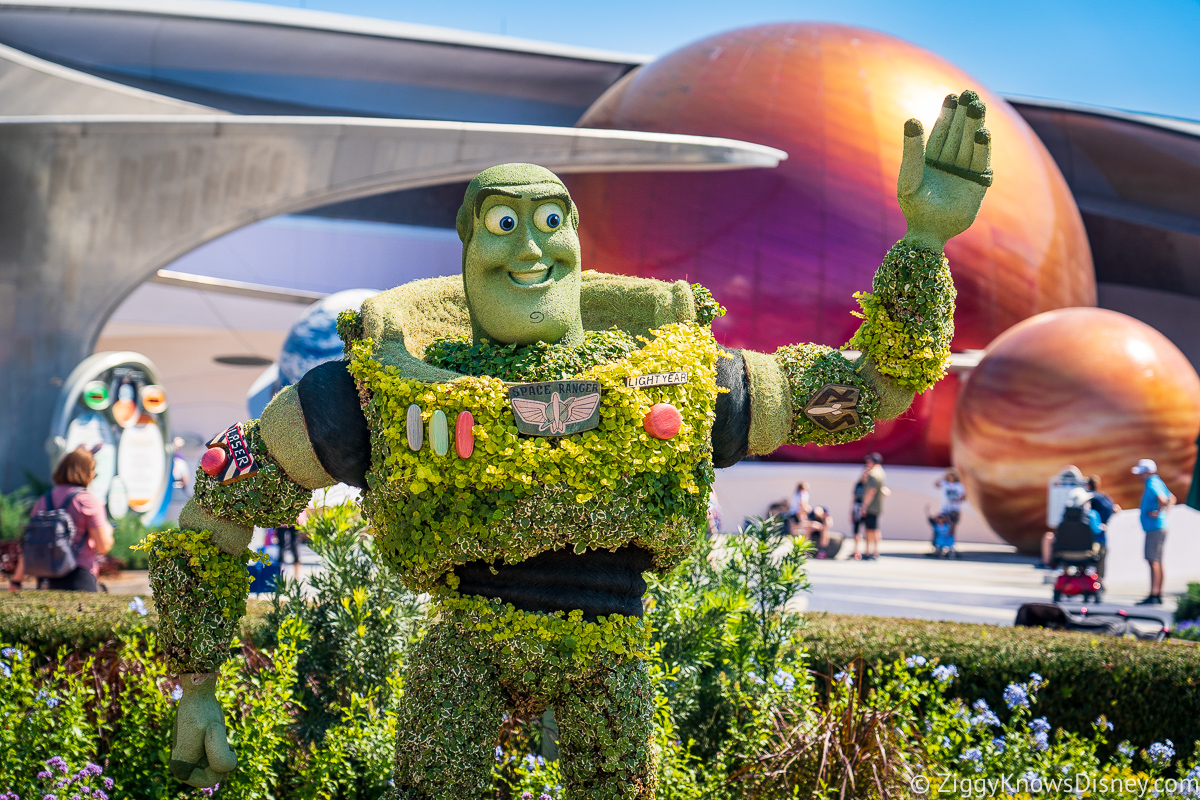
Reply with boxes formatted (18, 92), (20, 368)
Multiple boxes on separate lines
(170, 673), (238, 788)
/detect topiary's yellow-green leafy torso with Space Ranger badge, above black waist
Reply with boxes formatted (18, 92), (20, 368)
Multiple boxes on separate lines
(348, 323), (719, 591)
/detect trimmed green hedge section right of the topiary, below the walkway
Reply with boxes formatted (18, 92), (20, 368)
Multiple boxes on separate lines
(800, 613), (1200, 759)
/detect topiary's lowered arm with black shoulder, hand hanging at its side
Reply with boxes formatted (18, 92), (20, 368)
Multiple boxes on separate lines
(144, 362), (368, 787)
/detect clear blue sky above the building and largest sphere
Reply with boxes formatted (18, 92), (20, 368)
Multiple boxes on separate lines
(253, 0), (1200, 119)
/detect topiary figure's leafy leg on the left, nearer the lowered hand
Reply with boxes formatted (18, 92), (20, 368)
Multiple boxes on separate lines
(395, 622), (506, 800)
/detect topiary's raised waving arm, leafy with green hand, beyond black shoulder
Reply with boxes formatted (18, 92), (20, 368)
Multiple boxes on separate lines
(724, 91), (992, 453)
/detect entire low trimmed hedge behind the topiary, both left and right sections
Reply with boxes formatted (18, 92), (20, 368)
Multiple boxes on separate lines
(9, 591), (1200, 758)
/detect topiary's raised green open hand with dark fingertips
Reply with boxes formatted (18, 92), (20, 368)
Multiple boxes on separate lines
(896, 90), (991, 253)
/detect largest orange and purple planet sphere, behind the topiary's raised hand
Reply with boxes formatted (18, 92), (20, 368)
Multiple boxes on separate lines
(568, 23), (1096, 465)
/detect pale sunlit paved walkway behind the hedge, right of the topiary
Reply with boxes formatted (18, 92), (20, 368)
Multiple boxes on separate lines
(797, 540), (1175, 625)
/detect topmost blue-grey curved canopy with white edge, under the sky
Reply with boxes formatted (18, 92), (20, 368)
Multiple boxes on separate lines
(0, 0), (647, 125)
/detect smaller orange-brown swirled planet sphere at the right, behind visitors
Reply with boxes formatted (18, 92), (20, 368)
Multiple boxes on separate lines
(953, 308), (1200, 553)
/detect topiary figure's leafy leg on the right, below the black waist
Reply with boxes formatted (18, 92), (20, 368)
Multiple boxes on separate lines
(554, 656), (655, 800)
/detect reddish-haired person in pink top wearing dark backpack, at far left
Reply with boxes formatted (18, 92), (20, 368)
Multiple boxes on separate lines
(8, 447), (113, 591)
